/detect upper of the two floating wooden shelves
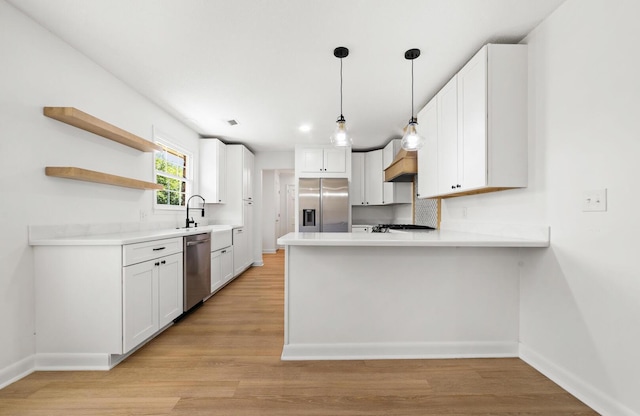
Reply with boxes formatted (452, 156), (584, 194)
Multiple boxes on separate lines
(44, 107), (162, 152)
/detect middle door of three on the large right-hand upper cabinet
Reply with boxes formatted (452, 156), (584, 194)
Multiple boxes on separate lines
(436, 76), (460, 194)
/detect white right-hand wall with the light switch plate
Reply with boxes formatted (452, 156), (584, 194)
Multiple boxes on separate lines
(443, 0), (640, 415)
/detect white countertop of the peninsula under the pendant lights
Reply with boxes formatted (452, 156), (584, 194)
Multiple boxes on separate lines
(278, 230), (549, 247)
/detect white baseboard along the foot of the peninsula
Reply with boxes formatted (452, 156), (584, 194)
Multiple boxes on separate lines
(281, 342), (518, 361)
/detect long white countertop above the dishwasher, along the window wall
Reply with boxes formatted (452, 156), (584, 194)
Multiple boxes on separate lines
(29, 225), (233, 246)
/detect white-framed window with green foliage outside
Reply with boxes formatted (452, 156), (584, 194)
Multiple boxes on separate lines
(154, 136), (191, 209)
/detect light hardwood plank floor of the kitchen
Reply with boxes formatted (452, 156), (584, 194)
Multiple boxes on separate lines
(0, 251), (597, 416)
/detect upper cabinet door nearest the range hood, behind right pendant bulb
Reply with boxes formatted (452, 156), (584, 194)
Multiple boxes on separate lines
(416, 98), (438, 198)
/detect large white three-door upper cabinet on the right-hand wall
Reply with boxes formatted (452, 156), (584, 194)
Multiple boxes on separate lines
(418, 44), (527, 198)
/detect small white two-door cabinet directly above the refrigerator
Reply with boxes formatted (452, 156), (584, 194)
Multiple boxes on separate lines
(296, 145), (351, 178)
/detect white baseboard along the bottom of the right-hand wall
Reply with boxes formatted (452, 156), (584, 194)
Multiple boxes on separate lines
(519, 344), (640, 416)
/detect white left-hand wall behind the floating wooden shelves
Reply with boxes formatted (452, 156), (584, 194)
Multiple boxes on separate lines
(0, 0), (198, 386)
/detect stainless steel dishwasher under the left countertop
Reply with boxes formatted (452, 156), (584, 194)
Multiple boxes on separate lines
(184, 233), (211, 312)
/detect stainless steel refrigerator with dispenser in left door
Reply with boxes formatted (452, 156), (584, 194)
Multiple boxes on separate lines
(298, 178), (350, 233)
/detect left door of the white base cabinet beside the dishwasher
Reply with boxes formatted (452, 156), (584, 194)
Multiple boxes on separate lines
(122, 260), (160, 353)
